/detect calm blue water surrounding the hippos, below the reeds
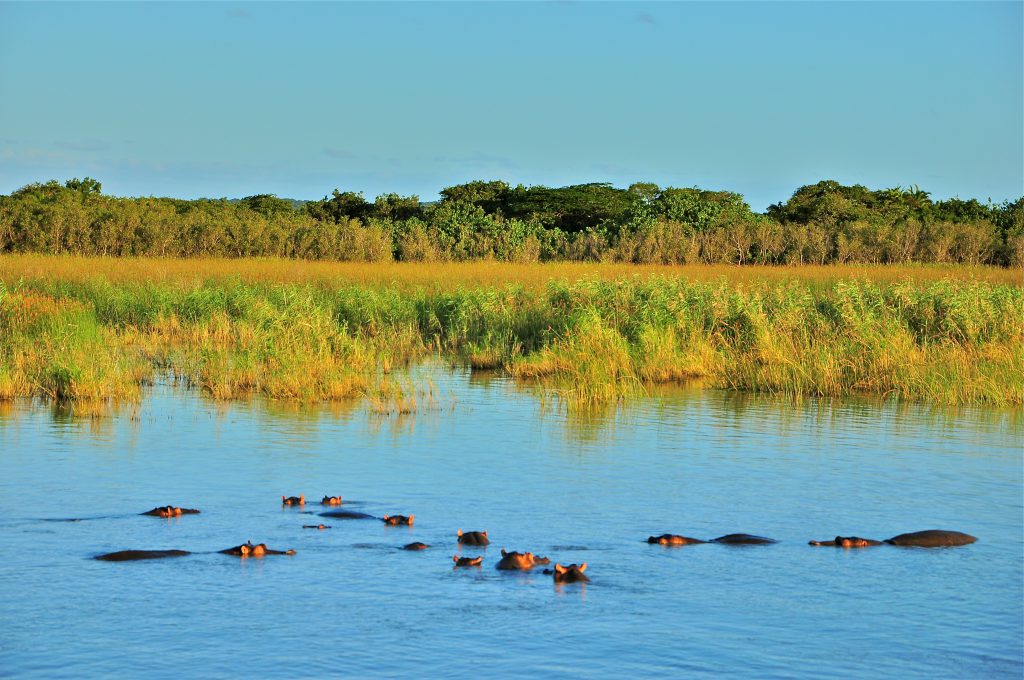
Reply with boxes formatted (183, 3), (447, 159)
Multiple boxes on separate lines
(0, 372), (1024, 678)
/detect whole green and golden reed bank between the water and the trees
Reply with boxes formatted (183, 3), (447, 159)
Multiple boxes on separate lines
(0, 256), (1024, 411)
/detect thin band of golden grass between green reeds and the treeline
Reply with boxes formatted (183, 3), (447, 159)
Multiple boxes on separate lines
(0, 254), (1024, 290)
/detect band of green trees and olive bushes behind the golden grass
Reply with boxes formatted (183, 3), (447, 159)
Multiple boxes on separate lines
(0, 177), (1024, 266)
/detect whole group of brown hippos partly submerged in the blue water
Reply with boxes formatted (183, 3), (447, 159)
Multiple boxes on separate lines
(96, 495), (978, 583)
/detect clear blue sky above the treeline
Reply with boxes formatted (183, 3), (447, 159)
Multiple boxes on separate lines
(0, 2), (1024, 210)
